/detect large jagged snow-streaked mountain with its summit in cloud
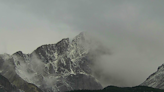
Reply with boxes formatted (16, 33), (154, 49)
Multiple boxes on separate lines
(0, 32), (110, 92)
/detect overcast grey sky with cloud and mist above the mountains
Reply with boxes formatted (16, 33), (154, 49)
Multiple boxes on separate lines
(0, 0), (164, 86)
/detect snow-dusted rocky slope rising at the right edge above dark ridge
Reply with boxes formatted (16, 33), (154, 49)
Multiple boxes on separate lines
(141, 64), (164, 89)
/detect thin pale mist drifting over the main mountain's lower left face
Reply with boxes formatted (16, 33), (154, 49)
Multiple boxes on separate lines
(14, 53), (56, 88)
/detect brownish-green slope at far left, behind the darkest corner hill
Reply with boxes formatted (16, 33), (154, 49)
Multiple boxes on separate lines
(0, 54), (42, 92)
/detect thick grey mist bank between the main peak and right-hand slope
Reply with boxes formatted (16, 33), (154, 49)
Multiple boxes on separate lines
(89, 33), (164, 87)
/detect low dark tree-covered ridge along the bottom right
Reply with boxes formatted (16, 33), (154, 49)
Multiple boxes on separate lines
(69, 86), (164, 92)
